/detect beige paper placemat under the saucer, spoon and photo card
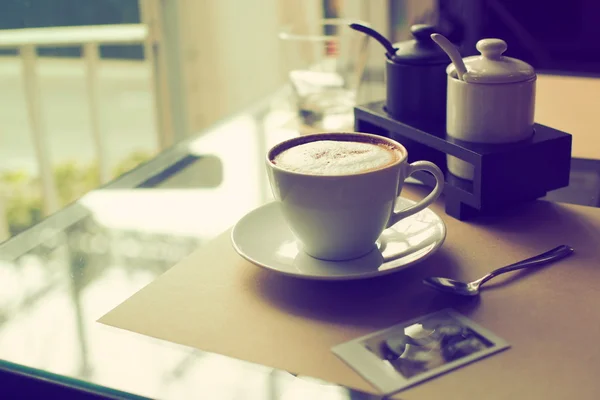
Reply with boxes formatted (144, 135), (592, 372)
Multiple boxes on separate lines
(100, 191), (600, 399)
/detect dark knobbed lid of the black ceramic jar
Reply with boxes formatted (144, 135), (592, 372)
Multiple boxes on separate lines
(392, 24), (448, 65)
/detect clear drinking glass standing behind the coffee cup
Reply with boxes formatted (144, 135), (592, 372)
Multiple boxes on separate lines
(279, 18), (369, 130)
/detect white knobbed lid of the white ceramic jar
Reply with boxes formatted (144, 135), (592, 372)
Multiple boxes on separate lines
(447, 39), (535, 83)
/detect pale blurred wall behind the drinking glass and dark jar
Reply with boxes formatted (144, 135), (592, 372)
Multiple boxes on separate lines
(163, 0), (398, 135)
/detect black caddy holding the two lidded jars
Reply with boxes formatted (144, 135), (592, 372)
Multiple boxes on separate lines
(354, 101), (572, 220)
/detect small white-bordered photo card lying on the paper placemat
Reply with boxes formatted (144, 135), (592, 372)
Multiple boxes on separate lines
(331, 309), (510, 395)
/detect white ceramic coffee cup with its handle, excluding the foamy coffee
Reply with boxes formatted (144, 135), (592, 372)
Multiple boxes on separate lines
(266, 133), (444, 260)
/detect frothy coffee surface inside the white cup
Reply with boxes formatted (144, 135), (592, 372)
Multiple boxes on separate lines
(272, 140), (400, 175)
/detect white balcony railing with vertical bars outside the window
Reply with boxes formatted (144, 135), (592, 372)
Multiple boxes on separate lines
(0, 0), (173, 242)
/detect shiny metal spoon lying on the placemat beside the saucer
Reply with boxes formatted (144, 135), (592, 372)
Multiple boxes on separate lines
(423, 245), (574, 296)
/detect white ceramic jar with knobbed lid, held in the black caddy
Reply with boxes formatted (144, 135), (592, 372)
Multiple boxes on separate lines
(446, 39), (536, 180)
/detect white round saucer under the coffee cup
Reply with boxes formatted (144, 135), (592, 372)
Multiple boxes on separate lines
(231, 198), (446, 281)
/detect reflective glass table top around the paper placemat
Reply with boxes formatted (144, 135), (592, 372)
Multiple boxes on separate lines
(0, 88), (600, 399)
